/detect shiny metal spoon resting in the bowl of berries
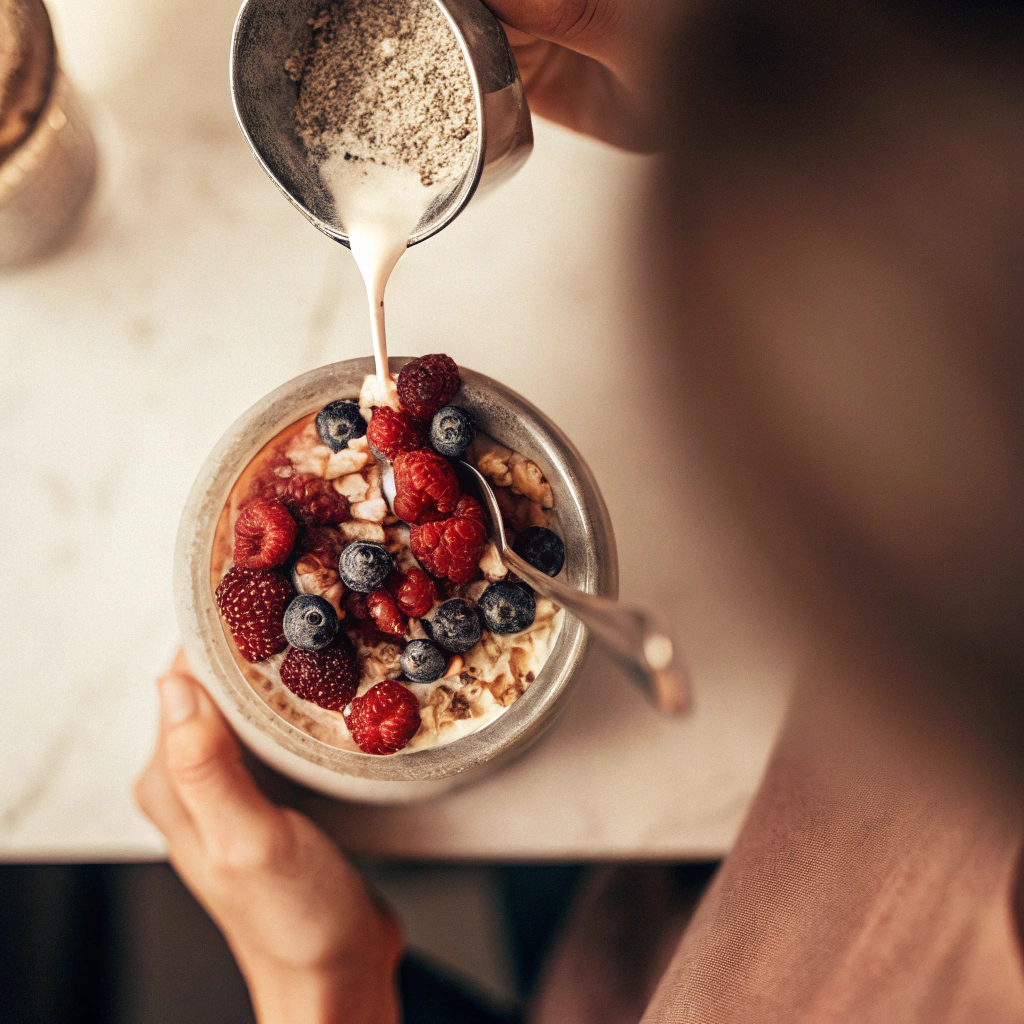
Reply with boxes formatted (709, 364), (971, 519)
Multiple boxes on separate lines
(380, 460), (692, 715)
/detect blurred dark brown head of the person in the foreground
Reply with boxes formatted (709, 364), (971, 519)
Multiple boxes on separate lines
(649, 0), (1024, 767)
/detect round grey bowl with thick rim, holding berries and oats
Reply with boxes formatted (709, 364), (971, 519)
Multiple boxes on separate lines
(174, 358), (618, 803)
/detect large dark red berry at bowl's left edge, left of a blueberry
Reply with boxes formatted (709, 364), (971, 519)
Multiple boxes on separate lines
(216, 565), (295, 662)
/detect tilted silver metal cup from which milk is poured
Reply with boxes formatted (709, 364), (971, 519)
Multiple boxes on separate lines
(230, 0), (534, 246)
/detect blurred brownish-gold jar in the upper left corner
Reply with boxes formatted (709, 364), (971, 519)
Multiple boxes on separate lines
(0, 0), (96, 269)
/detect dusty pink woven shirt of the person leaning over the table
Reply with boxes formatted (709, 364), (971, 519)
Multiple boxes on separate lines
(532, 700), (1024, 1024)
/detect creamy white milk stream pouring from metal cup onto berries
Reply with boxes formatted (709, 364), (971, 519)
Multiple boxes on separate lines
(321, 155), (451, 409)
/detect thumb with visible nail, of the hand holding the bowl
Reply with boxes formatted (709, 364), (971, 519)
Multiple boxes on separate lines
(160, 672), (279, 857)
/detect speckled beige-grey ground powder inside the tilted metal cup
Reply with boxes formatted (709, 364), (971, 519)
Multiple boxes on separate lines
(285, 0), (477, 186)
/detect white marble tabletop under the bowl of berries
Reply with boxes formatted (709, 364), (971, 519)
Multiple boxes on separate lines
(0, 0), (790, 859)
